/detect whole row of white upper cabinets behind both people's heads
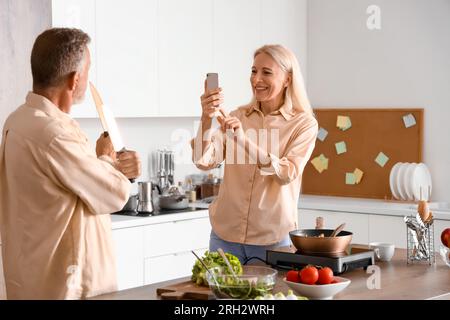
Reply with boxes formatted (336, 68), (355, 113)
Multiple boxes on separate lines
(52, 0), (306, 117)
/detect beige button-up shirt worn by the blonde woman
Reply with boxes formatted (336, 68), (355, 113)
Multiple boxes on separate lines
(193, 103), (318, 245)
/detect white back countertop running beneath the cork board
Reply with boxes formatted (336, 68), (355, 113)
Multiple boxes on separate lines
(298, 195), (450, 220)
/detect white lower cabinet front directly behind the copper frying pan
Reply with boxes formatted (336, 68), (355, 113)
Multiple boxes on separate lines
(298, 209), (369, 244)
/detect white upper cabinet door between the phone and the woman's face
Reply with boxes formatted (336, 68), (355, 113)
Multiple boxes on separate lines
(213, 0), (262, 111)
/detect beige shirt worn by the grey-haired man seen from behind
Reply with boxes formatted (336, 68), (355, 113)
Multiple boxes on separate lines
(0, 93), (130, 299)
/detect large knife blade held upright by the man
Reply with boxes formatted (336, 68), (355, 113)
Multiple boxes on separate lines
(89, 81), (135, 183)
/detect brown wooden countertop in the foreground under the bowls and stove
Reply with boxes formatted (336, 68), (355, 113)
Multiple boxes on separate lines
(91, 249), (450, 300)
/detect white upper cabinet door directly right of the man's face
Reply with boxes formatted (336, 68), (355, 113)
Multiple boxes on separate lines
(96, 0), (158, 117)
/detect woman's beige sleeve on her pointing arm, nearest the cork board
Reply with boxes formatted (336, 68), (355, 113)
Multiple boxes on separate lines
(260, 119), (318, 185)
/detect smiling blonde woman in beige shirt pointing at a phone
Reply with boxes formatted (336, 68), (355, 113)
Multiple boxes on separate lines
(193, 45), (317, 262)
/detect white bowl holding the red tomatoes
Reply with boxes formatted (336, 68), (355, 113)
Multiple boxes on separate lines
(283, 276), (351, 300)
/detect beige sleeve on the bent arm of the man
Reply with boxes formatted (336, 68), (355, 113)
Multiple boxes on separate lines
(47, 134), (131, 214)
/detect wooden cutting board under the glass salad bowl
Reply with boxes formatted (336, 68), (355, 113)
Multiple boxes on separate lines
(156, 281), (215, 300)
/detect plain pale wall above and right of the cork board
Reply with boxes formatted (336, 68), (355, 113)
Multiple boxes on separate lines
(308, 0), (450, 201)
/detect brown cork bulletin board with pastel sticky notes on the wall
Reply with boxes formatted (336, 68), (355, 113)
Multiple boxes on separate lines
(302, 108), (423, 199)
